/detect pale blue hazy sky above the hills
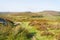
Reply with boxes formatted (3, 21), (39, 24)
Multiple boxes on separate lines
(0, 0), (60, 12)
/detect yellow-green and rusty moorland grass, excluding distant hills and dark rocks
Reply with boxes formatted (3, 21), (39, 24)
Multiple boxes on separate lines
(0, 13), (60, 40)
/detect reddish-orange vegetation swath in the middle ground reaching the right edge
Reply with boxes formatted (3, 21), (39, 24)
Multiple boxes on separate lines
(29, 19), (60, 30)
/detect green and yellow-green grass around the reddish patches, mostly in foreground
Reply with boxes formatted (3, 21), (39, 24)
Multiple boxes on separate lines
(0, 16), (60, 40)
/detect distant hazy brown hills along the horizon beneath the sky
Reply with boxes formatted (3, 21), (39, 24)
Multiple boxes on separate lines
(0, 11), (60, 16)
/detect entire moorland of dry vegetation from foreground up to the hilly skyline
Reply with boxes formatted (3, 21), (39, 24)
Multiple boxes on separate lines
(0, 11), (60, 40)
